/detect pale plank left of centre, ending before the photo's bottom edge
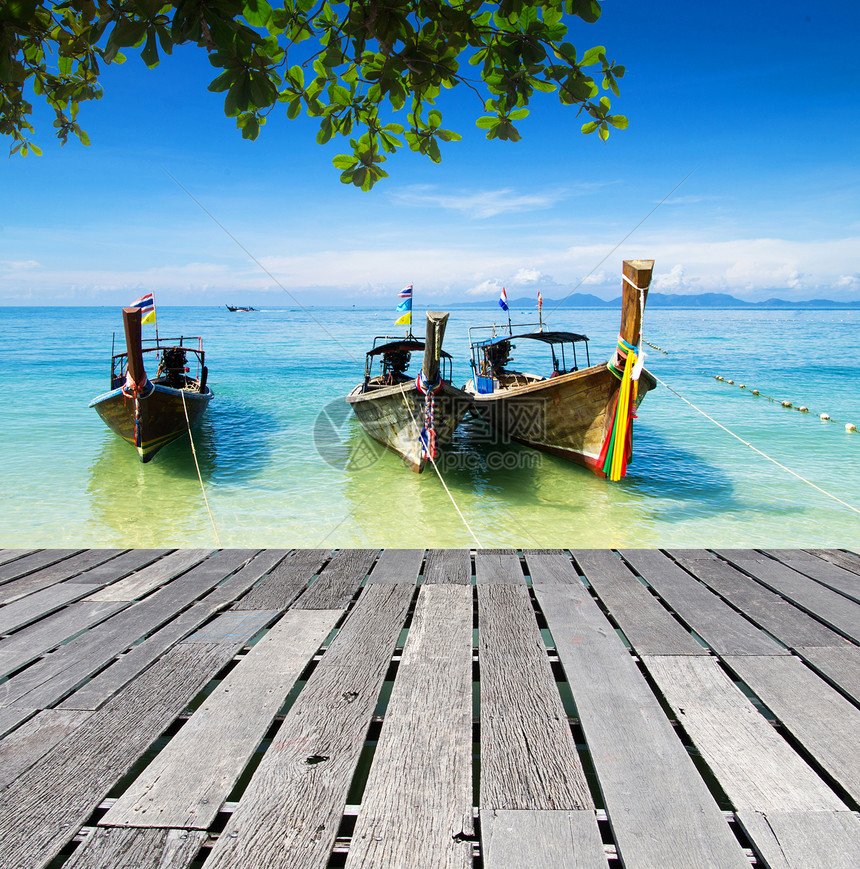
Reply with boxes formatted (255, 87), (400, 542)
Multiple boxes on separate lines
(100, 610), (343, 830)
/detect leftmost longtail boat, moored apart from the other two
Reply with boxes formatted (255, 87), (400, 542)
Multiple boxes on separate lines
(90, 308), (212, 462)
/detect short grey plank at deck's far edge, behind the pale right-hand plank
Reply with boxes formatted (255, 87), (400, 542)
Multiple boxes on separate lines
(572, 549), (707, 655)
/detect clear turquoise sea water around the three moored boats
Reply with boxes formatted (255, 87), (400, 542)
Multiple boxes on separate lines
(0, 300), (860, 548)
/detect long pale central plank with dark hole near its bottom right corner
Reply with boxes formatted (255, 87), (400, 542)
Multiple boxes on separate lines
(346, 584), (474, 869)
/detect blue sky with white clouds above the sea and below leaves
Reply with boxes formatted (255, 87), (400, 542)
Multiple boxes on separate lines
(0, 0), (860, 305)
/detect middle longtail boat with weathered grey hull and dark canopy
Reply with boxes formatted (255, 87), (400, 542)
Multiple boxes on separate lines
(346, 311), (469, 474)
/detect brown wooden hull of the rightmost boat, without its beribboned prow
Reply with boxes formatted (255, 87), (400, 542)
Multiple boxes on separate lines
(465, 365), (657, 477)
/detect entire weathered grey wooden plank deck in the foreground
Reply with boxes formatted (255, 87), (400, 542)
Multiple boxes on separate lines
(0, 549), (860, 869)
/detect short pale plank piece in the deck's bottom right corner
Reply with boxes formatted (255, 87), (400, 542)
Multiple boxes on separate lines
(737, 810), (860, 869)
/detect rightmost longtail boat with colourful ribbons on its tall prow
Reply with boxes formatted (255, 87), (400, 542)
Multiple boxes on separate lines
(463, 260), (657, 479)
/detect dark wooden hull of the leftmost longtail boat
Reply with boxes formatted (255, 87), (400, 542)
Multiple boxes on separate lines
(90, 384), (212, 462)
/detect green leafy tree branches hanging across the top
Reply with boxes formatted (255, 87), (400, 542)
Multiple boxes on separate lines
(0, 0), (627, 190)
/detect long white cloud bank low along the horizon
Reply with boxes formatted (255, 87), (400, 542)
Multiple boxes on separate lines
(6, 230), (860, 304)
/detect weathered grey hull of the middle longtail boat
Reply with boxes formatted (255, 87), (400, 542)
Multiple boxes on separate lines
(346, 380), (469, 474)
